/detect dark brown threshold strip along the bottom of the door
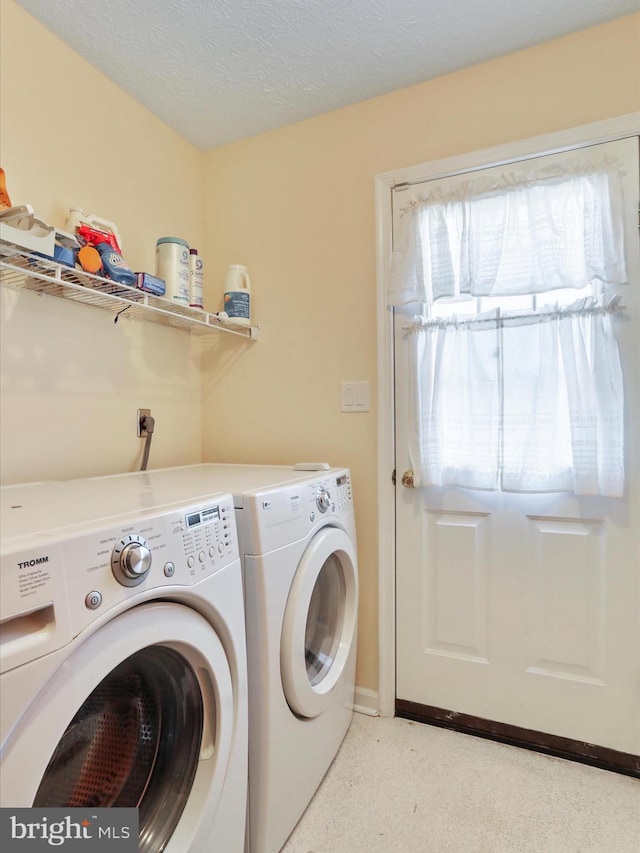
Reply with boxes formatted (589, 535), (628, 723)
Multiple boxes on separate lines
(396, 699), (640, 779)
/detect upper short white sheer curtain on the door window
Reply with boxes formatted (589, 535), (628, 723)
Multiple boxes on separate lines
(388, 159), (626, 305)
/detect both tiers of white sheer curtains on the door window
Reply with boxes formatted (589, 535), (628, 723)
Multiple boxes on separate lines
(388, 153), (627, 497)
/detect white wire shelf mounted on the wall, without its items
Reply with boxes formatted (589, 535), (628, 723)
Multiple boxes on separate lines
(0, 241), (259, 340)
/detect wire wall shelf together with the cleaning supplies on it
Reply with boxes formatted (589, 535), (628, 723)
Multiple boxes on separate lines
(0, 168), (258, 339)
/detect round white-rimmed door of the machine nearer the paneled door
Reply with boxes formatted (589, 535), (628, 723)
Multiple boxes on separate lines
(280, 527), (358, 717)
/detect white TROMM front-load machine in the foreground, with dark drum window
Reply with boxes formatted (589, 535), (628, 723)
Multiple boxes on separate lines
(0, 475), (248, 853)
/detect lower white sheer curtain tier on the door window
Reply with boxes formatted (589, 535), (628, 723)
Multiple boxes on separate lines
(409, 299), (624, 497)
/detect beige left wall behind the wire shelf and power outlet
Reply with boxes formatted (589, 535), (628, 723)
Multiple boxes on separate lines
(0, 0), (203, 483)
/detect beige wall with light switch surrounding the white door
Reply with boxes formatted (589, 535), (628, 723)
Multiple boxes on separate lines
(203, 16), (640, 689)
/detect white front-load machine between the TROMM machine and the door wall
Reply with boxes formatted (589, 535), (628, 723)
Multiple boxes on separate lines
(101, 464), (358, 853)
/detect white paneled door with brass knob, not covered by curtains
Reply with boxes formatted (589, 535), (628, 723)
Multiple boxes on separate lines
(394, 138), (640, 754)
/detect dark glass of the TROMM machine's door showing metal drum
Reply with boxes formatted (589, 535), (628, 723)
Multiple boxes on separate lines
(33, 645), (203, 853)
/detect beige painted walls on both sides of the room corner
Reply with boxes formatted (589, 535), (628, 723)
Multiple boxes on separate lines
(0, 0), (640, 689)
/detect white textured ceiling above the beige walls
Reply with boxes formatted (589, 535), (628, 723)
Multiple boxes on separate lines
(12, 0), (639, 149)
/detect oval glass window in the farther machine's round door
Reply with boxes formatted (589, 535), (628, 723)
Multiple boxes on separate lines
(304, 554), (345, 685)
